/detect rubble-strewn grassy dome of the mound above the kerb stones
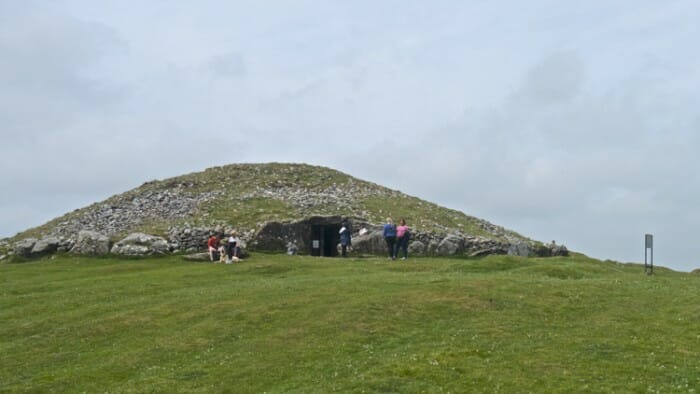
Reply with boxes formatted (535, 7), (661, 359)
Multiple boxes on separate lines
(11, 163), (524, 241)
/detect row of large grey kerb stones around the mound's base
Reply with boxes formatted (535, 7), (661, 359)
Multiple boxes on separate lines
(6, 216), (568, 258)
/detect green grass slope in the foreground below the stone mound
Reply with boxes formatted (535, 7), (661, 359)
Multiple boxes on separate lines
(0, 254), (700, 393)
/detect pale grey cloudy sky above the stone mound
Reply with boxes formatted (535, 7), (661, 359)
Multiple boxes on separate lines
(0, 0), (700, 271)
